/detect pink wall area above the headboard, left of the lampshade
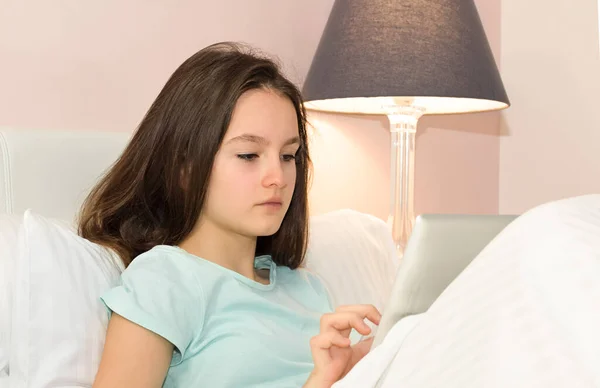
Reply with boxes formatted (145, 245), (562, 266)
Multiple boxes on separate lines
(0, 0), (333, 131)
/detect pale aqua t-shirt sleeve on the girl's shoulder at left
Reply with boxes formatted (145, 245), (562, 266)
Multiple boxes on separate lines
(101, 251), (205, 365)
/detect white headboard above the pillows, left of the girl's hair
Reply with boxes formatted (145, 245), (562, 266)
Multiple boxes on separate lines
(0, 128), (131, 221)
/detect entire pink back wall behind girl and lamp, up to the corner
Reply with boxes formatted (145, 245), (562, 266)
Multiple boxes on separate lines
(0, 0), (500, 219)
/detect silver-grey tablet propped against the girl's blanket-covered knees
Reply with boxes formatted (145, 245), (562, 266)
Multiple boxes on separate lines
(371, 214), (516, 348)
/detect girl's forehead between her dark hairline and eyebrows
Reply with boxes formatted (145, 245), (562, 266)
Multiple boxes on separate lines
(225, 89), (298, 141)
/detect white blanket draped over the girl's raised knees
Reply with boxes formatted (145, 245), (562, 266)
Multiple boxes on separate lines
(336, 195), (600, 388)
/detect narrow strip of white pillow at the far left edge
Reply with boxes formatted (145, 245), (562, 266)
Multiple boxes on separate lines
(0, 214), (23, 378)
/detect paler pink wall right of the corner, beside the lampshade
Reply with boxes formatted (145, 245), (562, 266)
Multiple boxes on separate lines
(499, 0), (600, 213)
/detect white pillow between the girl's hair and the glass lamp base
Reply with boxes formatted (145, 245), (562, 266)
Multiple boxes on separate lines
(306, 209), (400, 311)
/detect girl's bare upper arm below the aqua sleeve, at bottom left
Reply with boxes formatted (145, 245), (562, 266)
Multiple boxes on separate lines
(93, 314), (173, 388)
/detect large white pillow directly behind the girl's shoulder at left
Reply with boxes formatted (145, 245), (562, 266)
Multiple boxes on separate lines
(10, 210), (123, 388)
